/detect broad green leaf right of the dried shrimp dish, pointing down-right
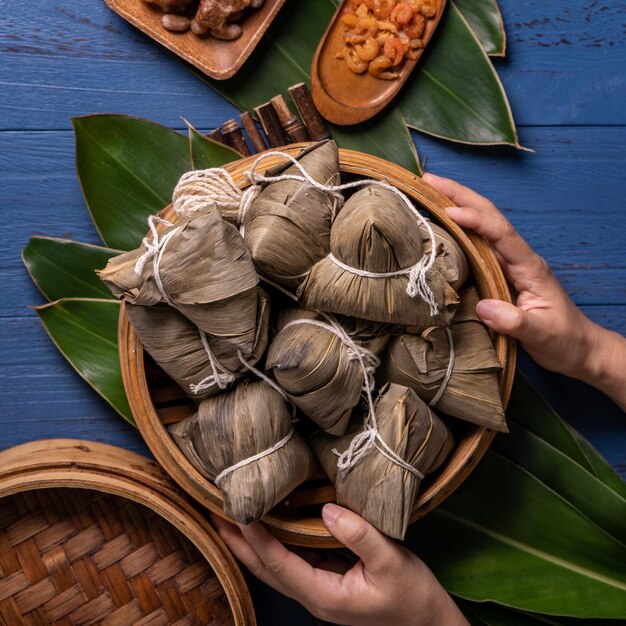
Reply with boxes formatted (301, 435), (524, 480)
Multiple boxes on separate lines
(399, 2), (520, 147)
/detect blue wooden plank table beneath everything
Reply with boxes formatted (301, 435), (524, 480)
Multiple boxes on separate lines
(0, 0), (626, 624)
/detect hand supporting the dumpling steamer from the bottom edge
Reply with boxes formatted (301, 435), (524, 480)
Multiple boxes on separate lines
(212, 504), (468, 626)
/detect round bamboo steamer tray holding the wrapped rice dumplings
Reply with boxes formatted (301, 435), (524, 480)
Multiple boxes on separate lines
(119, 144), (515, 548)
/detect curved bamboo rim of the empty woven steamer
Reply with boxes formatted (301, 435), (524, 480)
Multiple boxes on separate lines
(0, 439), (256, 626)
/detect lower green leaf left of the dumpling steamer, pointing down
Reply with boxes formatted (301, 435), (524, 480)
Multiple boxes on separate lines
(36, 298), (135, 425)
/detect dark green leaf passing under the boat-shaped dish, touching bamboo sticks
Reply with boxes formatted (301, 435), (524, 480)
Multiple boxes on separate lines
(198, 0), (420, 172)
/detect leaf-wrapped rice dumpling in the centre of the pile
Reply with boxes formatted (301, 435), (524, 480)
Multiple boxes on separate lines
(266, 307), (389, 435)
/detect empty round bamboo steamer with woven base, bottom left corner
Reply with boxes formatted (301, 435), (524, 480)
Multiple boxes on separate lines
(0, 439), (256, 626)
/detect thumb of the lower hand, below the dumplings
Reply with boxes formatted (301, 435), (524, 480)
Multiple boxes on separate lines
(322, 504), (397, 574)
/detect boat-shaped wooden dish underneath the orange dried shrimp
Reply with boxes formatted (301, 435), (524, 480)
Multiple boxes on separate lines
(311, 0), (446, 125)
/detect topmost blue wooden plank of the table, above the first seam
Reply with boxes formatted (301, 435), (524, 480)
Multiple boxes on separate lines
(0, 0), (626, 130)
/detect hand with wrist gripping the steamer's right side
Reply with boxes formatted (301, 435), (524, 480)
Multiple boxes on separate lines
(424, 174), (626, 408)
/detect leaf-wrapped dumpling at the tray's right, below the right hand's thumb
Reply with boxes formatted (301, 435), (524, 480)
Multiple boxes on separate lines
(377, 288), (507, 432)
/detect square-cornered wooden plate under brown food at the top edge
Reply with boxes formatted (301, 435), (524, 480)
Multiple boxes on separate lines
(104, 0), (285, 80)
